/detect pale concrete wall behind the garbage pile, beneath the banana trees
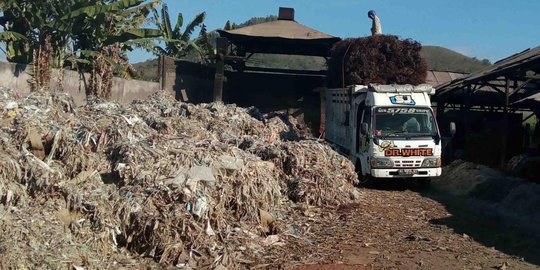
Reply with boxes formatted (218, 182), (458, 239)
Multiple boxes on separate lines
(0, 61), (161, 105)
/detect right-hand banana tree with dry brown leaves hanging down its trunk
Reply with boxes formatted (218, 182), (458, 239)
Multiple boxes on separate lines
(59, 0), (161, 98)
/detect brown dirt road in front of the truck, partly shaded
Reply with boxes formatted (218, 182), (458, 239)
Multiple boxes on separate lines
(274, 185), (540, 269)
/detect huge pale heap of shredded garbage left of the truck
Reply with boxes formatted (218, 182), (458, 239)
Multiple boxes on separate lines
(0, 89), (360, 269)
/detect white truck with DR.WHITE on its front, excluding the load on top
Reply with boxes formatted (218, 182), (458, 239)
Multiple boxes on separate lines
(324, 84), (455, 185)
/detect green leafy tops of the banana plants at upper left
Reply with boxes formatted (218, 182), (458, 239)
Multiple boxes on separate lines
(0, 0), (161, 67)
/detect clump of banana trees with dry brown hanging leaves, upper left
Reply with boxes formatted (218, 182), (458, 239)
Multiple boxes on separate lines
(0, 0), (161, 96)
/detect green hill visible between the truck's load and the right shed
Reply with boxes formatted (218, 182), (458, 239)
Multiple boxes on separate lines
(420, 46), (491, 73)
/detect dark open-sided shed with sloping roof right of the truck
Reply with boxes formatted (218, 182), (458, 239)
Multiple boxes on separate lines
(433, 47), (540, 167)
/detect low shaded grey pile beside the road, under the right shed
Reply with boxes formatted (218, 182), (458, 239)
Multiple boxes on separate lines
(433, 160), (540, 224)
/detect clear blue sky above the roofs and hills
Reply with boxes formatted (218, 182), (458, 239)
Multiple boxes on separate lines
(124, 0), (540, 62)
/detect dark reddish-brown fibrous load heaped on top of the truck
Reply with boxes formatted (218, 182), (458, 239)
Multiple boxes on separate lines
(328, 35), (427, 87)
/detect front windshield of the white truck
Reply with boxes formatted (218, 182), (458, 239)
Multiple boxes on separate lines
(374, 107), (437, 137)
